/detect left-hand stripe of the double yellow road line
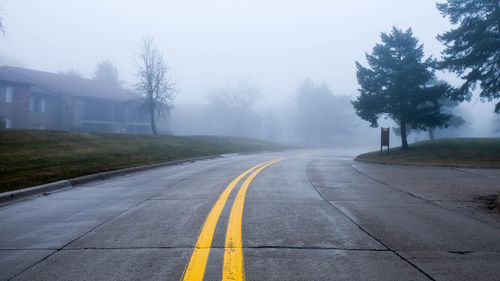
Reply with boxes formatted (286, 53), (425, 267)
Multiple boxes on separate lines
(182, 161), (272, 281)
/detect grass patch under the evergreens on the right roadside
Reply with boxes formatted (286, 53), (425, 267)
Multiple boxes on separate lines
(358, 138), (500, 168)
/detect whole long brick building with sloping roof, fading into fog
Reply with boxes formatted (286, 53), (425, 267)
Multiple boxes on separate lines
(0, 66), (151, 134)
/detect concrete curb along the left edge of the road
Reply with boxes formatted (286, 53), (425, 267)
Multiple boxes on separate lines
(0, 155), (222, 205)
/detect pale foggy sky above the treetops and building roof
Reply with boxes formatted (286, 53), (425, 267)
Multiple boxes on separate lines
(0, 0), (493, 136)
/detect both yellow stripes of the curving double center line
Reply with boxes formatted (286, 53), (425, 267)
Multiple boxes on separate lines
(183, 158), (284, 281)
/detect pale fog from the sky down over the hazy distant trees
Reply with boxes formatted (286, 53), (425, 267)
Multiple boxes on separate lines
(0, 0), (500, 144)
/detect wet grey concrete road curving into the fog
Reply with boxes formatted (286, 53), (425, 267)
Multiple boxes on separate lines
(0, 150), (500, 280)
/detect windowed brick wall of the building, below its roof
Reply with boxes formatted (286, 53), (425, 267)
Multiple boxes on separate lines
(0, 83), (154, 134)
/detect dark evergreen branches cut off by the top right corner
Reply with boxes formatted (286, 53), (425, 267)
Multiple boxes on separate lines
(437, 0), (500, 113)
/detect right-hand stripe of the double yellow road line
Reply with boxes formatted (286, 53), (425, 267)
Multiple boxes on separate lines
(222, 159), (284, 280)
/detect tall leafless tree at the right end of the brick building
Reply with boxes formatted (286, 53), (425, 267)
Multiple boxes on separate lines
(135, 37), (176, 135)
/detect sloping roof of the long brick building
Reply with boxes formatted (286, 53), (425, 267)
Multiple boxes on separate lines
(0, 66), (134, 100)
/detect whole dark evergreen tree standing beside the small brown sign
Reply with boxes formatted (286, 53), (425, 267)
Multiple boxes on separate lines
(352, 27), (450, 149)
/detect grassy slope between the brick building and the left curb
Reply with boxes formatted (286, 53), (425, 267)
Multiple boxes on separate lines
(0, 129), (285, 192)
